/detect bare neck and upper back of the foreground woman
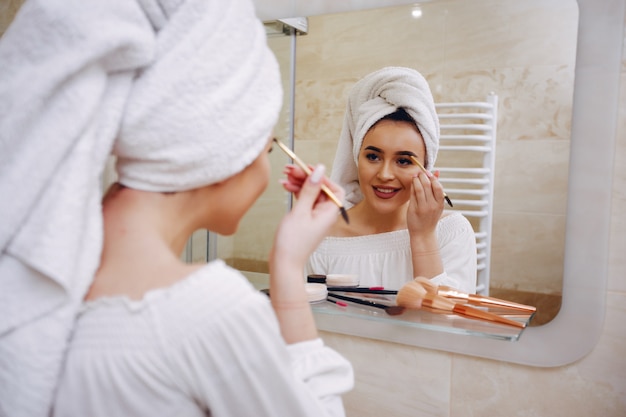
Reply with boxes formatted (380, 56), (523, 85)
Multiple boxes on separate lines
(86, 189), (197, 299)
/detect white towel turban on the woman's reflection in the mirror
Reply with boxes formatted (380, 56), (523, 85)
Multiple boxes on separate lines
(331, 67), (439, 208)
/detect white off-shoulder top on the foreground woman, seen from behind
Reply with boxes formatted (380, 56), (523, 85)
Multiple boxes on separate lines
(54, 260), (354, 417)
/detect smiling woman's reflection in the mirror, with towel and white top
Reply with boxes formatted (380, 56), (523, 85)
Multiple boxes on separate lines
(288, 67), (476, 293)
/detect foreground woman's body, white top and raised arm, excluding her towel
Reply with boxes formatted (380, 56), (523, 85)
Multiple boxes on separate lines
(54, 141), (352, 416)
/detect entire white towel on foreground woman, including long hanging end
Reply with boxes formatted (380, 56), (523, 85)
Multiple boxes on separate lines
(0, 0), (282, 417)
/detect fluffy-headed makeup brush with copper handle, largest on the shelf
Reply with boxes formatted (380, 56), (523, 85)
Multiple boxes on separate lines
(396, 280), (526, 329)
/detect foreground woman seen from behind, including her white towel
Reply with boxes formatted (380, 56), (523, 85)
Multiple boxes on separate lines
(0, 0), (353, 417)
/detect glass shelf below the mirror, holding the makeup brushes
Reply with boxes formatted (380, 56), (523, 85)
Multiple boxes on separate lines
(311, 294), (534, 342)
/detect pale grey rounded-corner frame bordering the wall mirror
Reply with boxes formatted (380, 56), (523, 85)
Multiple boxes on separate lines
(255, 0), (626, 367)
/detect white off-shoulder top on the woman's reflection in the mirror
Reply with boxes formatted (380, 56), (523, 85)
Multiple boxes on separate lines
(305, 212), (477, 293)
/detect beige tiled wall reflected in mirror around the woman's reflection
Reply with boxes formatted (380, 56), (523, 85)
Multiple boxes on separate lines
(295, 0), (578, 294)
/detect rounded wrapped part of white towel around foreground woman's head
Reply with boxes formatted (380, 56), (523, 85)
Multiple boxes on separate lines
(113, 0), (282, 191)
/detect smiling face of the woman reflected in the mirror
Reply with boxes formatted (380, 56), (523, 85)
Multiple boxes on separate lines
(358, 120), (426, 213)
